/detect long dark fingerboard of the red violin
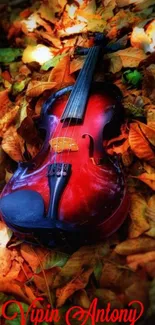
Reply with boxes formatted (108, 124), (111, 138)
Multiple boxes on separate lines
(61, 46), (100, 122)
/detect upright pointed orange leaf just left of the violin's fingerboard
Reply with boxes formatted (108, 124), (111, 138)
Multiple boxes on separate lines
(48, 55), (75, 89)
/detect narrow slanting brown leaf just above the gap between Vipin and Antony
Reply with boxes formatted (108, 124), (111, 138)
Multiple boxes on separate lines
(56, 268), (93, 308)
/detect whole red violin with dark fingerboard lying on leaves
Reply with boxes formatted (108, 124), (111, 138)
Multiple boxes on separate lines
(0, 35), (129, 247)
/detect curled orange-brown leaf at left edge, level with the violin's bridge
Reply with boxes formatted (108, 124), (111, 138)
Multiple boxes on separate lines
(2, 126), (24, 162)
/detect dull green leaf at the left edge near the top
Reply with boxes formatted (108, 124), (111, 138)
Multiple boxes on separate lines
(0, 48), (22, 63)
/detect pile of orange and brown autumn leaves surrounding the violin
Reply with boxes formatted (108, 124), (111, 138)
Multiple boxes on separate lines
(0, 0), (155, 325)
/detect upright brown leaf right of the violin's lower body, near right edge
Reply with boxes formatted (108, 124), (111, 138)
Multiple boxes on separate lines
(129, 193), (150, 238)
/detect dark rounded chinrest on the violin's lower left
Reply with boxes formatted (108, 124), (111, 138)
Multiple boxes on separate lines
(0, 190), (75, 233)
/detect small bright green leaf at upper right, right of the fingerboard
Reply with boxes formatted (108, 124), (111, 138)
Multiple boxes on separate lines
(122, 70), (142, 87)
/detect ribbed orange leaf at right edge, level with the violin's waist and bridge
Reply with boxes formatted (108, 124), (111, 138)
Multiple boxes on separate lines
(129, 123), (155, 167)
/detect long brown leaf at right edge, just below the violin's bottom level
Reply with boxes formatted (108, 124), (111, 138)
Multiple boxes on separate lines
(115, 236), (155, 256)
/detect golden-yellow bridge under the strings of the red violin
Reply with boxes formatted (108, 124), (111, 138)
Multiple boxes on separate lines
(49, 137), (79, 153)
